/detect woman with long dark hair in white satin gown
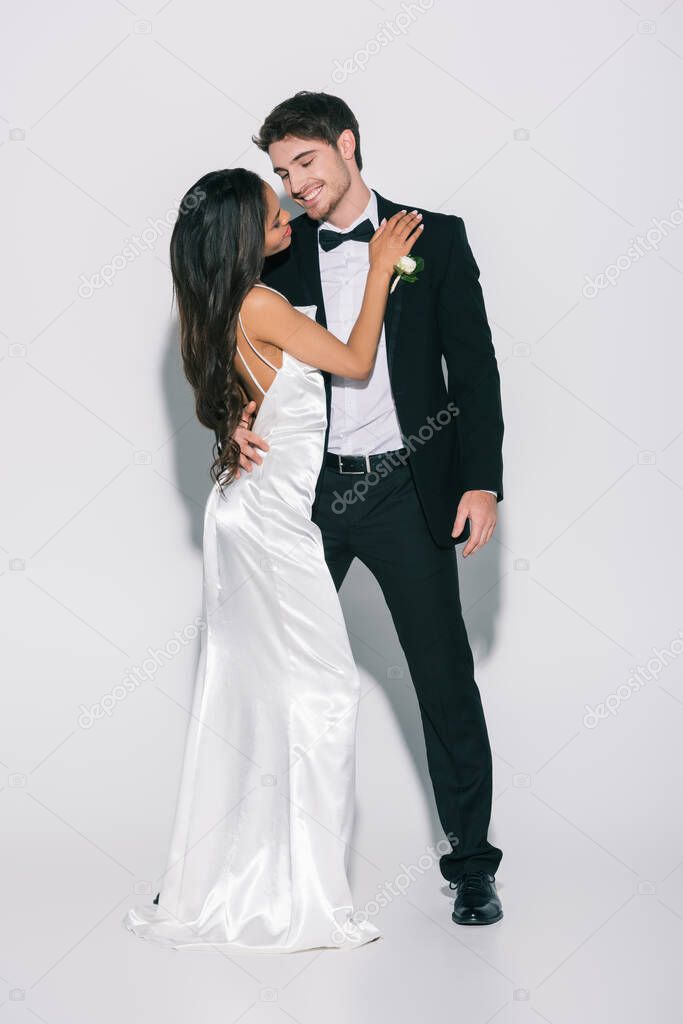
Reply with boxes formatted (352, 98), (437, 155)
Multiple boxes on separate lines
(123, 168), (422, 953)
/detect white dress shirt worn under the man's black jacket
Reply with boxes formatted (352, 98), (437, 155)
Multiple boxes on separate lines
(317, 188), (496, 495)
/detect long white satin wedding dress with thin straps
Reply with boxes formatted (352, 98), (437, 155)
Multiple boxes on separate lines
(123, 285), (381, 953)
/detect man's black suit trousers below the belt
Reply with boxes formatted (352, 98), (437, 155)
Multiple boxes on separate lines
(313, 462), (503, 882)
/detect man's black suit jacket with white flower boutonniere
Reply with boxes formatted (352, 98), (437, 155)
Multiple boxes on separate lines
(261, 191), (504, 548)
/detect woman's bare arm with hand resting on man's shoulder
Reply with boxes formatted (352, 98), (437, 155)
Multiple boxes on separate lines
(242, 211), (422, 380)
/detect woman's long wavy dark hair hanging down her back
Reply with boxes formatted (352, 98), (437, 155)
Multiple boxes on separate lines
(171, 167), (266, 494)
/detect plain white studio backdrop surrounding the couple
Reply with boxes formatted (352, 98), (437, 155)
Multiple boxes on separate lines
(0, 0), (683, 1024)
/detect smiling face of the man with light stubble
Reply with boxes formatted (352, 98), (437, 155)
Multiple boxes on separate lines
(268, 132), (354, 220)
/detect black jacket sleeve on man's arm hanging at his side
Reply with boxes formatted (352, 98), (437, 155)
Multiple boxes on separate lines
(437, 216), (504, 502)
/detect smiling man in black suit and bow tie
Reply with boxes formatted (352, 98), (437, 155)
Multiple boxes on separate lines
(240, 92), (503, 925)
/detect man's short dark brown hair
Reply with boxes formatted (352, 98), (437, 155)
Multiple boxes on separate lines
(252, 89), (362, 171)
